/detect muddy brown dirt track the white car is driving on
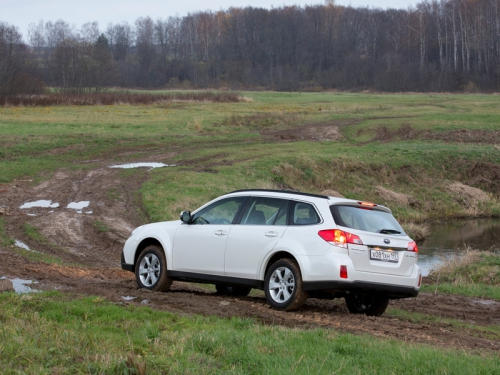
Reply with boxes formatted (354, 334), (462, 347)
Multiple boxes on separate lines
(0, 161), (500, 352)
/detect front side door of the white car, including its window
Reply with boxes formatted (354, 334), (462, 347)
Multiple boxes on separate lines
(172, 197), (246, 275)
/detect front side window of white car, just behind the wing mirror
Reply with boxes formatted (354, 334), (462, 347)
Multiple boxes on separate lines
(193, 197), (245, 224)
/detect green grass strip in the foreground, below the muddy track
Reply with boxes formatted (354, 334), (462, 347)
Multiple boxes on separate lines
(0, 293), (500, 374)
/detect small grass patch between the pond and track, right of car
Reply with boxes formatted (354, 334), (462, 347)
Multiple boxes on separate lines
(422, 252), (500, 301)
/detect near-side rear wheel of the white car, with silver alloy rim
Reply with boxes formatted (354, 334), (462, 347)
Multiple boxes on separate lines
(264, 258), (307, 311)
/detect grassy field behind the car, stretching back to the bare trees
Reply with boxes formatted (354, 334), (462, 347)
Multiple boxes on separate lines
(0, 91), (500, 226)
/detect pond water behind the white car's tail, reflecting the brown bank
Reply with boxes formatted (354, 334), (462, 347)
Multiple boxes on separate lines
(418, 219), (500, 276)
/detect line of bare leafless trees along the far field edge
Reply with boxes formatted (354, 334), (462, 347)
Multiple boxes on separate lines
(0, 0), (500, 94)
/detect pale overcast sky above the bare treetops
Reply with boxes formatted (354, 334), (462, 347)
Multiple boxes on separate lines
(0, 0), (418, 36)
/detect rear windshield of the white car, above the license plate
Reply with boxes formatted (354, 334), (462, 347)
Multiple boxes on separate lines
(330, 205), (405, 234)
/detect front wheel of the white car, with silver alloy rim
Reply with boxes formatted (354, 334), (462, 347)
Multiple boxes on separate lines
(135, 245), (172, 292)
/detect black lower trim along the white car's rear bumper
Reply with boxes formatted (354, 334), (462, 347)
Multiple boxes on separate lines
(304, 281), (418, 298)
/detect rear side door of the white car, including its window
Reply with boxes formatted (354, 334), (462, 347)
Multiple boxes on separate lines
(225, 197), (288, 279)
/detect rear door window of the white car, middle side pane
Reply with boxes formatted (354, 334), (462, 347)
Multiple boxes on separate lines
(241, 198), (288, 225)
